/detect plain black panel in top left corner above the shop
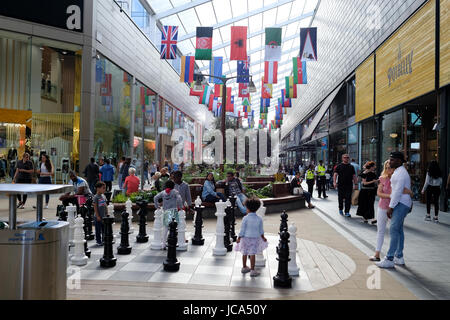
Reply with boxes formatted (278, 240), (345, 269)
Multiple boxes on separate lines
(0, 0), (84, 32)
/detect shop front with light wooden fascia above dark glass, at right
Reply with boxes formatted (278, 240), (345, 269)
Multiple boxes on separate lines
(356, 0), (446, 205)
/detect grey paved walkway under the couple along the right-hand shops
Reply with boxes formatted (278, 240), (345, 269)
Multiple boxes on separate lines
(305, 185), (450, 299)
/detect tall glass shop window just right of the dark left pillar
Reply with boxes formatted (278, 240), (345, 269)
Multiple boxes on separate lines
(94, 57), (131, 164)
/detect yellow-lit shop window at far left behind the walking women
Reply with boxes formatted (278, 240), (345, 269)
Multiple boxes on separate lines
(0, 31), (82, 182)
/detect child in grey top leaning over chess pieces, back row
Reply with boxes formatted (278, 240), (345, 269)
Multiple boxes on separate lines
(153, 180), (183, 248)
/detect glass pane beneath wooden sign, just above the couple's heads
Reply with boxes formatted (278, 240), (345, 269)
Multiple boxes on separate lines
(380, 110), (404, 162)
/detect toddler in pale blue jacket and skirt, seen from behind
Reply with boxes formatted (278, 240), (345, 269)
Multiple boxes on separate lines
(235, 197), (267, 277)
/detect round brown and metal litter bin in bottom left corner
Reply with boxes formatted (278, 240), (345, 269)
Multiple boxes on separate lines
(0, 221), (69, 300)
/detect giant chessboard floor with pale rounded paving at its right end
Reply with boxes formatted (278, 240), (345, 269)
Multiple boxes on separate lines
(68, 233), (356, 292)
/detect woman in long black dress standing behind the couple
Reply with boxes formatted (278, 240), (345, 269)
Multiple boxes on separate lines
(356, 161), (378, 224)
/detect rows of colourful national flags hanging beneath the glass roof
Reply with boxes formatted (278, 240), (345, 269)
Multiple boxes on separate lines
(160, 21), (317, 130)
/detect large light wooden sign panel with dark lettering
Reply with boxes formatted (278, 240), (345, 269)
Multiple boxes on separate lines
(376, 0), (436, 114)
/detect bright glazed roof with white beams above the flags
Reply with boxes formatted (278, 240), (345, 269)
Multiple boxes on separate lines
(146, 0), (320, 124)
